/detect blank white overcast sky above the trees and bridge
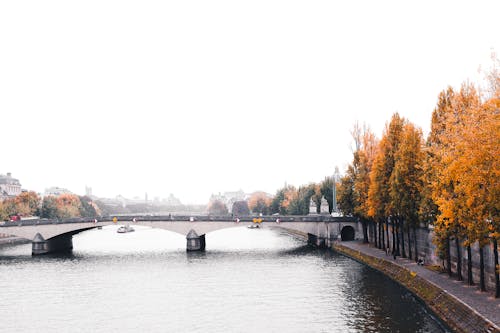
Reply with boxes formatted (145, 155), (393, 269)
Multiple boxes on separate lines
(0, 0), (500, 203)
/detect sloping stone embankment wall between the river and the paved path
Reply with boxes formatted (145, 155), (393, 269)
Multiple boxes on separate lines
(333, 243), (497, 333)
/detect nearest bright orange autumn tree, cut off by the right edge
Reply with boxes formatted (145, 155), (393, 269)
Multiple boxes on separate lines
(452, 82), (500, 297)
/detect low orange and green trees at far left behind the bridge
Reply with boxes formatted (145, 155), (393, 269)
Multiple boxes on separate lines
(0, 191), (100, 221)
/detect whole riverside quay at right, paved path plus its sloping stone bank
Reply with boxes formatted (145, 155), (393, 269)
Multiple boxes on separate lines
(333, 241), (500, 333)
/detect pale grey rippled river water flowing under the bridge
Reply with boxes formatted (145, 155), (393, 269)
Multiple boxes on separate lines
(0, 226), (448, 333)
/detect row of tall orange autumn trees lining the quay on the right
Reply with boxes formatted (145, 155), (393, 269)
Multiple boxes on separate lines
(338, 60), (500, 297)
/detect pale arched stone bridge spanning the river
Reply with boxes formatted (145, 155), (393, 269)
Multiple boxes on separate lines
(0, 215), (362, 255)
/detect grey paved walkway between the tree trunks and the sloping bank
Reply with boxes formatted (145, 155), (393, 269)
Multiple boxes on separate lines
(342, 241), (500, 327)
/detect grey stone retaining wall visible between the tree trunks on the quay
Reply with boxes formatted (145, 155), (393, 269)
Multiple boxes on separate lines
(370, 227), (495, 290)
